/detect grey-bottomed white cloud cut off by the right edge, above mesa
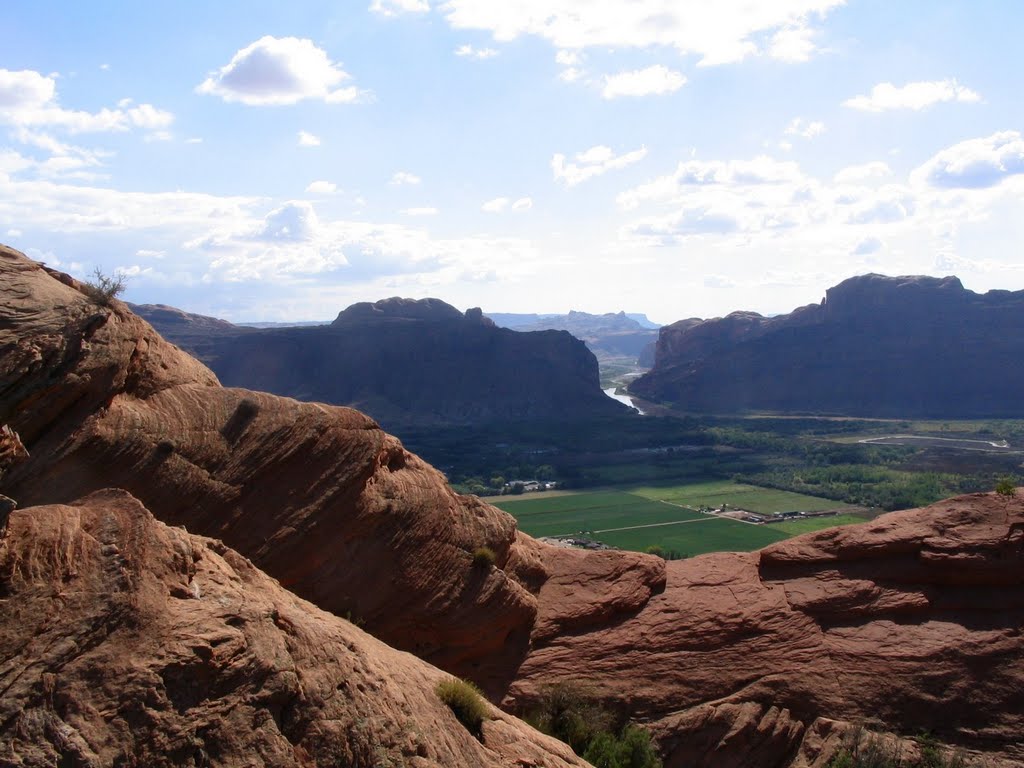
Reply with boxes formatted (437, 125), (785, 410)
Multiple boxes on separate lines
(912, 131), (1024, 189)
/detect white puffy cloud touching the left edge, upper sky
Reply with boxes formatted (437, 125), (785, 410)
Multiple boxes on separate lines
(0, 70), (174, 133)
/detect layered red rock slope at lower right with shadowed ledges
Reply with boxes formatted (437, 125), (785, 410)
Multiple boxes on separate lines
(506, 494), (1024, 768)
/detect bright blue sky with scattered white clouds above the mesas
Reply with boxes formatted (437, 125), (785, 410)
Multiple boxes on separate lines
(0, 0), (1024, 323)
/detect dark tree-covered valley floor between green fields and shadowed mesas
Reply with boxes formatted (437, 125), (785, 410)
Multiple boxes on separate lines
(401, 416), (1024, 511)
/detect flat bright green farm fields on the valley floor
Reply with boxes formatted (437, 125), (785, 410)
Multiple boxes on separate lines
(489, 481), (865, 557)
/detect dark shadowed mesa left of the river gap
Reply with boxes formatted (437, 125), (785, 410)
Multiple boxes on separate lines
(136, 298), (627, 427)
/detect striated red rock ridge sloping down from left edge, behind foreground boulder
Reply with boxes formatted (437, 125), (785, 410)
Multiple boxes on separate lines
(0, 249), (557, 692)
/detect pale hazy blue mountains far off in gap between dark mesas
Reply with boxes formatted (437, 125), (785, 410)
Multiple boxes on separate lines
(487, 310), (657, 360)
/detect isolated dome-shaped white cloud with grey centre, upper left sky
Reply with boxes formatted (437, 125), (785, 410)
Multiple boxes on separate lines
(196, 35), (365, 105)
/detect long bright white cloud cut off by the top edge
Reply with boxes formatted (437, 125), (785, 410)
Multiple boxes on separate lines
(441, 0), (845, 66)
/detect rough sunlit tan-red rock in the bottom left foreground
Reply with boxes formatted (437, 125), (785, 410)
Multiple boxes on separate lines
(0, 490), (587, 768)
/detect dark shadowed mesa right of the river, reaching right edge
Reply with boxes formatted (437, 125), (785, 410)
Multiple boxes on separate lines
(630, 274), (1024, 418)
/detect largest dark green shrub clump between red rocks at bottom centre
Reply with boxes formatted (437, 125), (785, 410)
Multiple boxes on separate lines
(524, 682), (662, 768)
